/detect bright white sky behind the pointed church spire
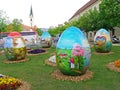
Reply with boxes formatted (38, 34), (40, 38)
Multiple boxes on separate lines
(0, 0), (89, 28)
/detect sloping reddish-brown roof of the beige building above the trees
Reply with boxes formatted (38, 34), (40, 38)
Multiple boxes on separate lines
(69, 0), (98, 20)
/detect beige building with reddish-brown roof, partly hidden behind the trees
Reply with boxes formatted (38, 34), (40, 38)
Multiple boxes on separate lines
(69, 0), (120, 41)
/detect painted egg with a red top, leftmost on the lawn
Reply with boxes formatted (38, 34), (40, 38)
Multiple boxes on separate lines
(4, 32), (26, 60)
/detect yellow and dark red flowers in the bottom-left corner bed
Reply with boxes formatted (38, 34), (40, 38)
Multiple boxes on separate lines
(0, 76), (22, 90)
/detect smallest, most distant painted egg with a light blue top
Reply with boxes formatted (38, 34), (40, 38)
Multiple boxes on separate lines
(41, 31), (52, 48)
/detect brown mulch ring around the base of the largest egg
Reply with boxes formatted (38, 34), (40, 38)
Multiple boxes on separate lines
(51, 70), (93, 82)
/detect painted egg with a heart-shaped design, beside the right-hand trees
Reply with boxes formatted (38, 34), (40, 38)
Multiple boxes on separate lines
(94, 29), (112, 53)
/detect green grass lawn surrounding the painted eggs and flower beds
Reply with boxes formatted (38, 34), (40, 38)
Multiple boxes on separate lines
(0, 46), (120, 90)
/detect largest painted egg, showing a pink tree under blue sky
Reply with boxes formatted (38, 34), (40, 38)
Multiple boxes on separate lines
(56, 26), (91, 75)
